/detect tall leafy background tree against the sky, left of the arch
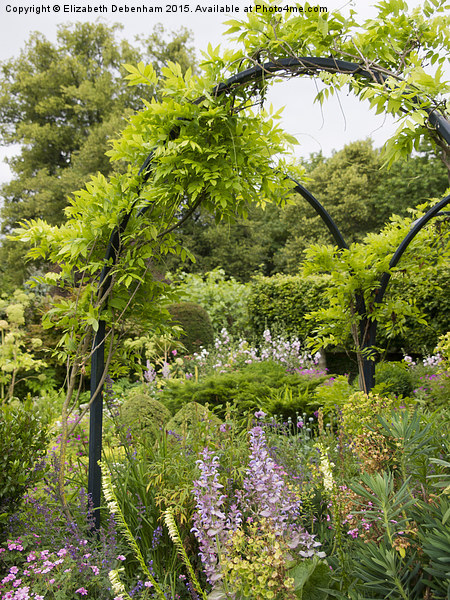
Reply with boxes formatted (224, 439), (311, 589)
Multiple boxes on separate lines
(0, 23), (194, 287)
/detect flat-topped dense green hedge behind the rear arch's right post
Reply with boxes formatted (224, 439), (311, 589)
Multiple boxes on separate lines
(248, 267), (450, 354)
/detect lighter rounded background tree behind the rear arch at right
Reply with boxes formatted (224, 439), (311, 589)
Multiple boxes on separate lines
(275, 140), (448, 273)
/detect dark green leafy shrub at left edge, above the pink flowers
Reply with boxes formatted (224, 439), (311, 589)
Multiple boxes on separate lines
(0, 400), (49, 537)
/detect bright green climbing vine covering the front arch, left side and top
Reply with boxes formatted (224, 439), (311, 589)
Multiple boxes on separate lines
(10, 0), (450, 510)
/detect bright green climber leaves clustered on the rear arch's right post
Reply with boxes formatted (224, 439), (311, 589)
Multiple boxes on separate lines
(303, 204), (448, 352)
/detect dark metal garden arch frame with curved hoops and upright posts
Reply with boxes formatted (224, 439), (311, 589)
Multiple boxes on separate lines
(88, 57), (450, 528)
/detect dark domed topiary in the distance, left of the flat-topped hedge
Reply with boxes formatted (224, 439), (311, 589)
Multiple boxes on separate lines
(167, 302), (214, 354)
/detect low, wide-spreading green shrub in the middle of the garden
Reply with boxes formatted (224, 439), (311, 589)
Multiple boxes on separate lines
(159, 361), (325, 414)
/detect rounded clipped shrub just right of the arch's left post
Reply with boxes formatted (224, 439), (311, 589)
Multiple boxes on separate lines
(120, 393), (172, 440)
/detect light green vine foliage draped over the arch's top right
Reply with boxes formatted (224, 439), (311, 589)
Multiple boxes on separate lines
(225, 0), (450, 170)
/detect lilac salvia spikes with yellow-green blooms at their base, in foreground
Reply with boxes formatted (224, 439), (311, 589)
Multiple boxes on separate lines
(193, 426), (325, 598)
